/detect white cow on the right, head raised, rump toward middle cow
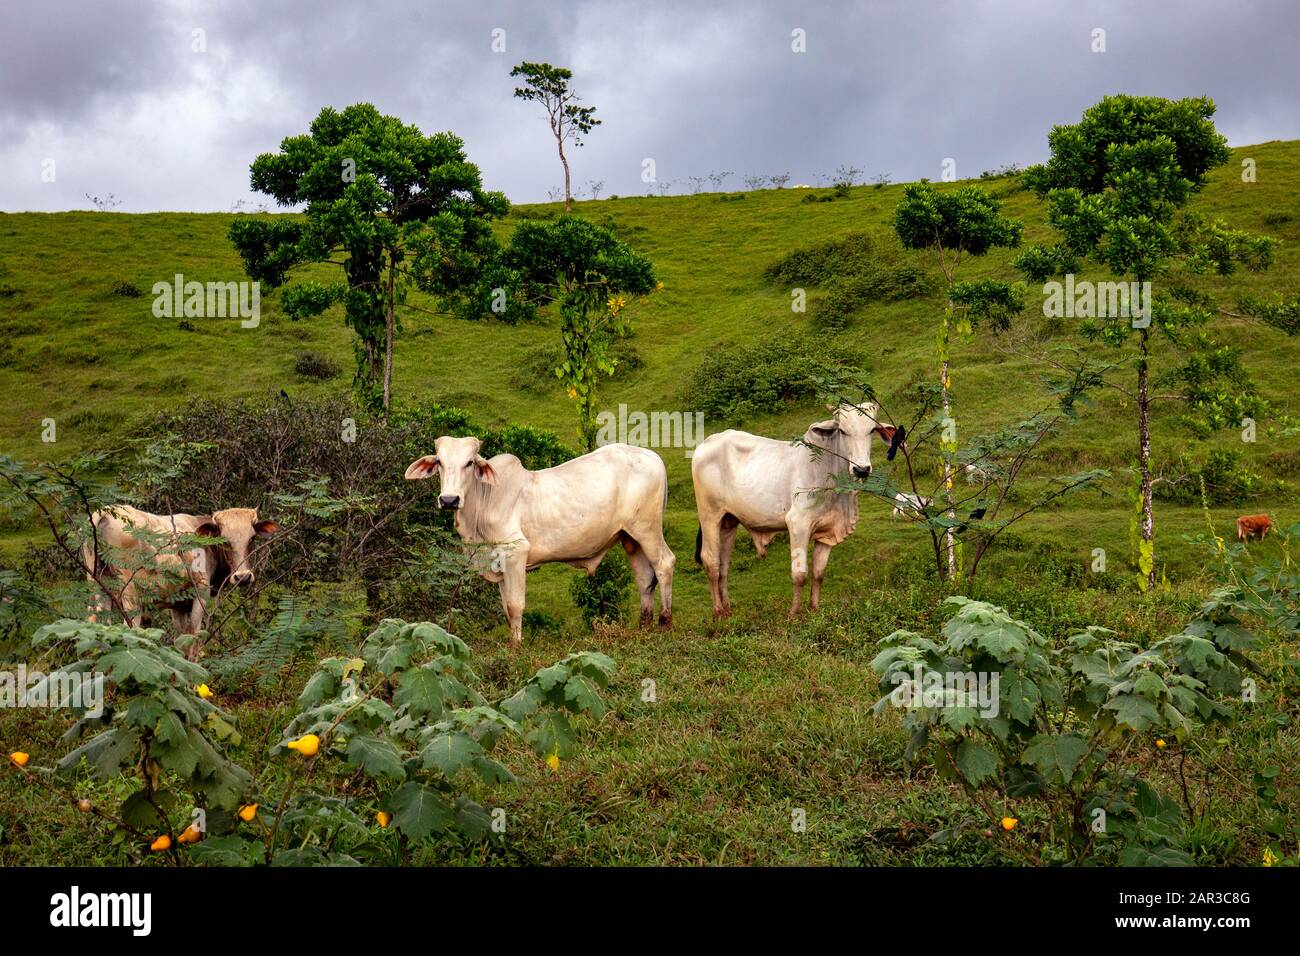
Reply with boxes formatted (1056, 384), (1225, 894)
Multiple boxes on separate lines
(690, 405), (896, 618)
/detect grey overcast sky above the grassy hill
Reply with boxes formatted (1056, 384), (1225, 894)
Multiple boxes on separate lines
(0, 0), (1300, 211)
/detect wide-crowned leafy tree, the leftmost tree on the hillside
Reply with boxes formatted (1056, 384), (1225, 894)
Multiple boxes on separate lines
(229, 103), (510, 411)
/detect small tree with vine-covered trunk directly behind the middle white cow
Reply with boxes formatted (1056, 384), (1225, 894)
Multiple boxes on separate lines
(502, 216), (657, 451)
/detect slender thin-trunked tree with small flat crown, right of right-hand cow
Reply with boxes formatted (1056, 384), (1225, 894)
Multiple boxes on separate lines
(893, 183), (1023, 578)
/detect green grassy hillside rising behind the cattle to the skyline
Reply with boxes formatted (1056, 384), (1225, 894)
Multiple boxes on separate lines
(0, 143), (1300, 607)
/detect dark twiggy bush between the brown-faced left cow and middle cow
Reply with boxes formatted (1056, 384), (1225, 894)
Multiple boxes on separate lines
(134, 395), (573, 598)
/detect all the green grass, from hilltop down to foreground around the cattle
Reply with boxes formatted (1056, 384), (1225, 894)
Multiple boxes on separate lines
(0, 143), (1300, 865)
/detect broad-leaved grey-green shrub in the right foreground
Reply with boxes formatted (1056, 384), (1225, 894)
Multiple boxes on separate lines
(871, 591), (1260, 866)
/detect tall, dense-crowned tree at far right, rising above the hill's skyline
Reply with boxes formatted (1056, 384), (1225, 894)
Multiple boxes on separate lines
(1017, 96), (1275, 588)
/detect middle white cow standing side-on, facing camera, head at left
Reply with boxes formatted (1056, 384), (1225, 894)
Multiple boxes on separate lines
(406, 436), (677, 644)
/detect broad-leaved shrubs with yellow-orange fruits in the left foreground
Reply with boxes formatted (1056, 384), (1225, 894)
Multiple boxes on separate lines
(27, 619), (614, 866)
